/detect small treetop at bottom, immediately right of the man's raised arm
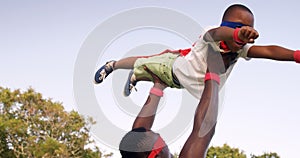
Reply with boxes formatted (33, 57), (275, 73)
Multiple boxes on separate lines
(206, 144), (247, 158)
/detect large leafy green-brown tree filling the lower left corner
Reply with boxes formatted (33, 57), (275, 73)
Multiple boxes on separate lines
(0, 87), (111, 158)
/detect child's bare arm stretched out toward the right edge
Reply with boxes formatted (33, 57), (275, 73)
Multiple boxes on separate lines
(247, 45), (299, 62)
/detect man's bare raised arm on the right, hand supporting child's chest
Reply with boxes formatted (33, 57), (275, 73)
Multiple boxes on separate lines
(180, 50), (225, 158)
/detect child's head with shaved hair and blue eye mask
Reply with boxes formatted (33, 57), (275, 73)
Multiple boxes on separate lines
(221, 4), (254, 52)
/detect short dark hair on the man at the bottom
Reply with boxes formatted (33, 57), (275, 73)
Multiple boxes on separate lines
(119, 127), (164, 158)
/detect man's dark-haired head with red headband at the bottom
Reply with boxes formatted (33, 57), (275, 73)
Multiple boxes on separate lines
(119, 128), (172, 158)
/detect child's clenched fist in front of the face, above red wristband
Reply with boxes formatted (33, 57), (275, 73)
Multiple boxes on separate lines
(238, 26), (259, 43)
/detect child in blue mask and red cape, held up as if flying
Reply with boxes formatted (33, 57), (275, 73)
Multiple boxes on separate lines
(95, 4), (300, 99)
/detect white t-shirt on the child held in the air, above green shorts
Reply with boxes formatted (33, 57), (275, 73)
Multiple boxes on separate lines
(173, 27), (251, 99)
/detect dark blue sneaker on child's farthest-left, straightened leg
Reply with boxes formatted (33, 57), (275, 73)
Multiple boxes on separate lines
(94, 60), (116, 84)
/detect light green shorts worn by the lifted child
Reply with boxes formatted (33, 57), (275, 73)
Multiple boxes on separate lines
(133, 53), (182, 88)
